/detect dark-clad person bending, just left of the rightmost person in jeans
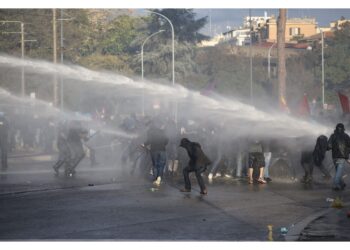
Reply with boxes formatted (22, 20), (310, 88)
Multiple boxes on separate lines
(300, 135), (331, 183)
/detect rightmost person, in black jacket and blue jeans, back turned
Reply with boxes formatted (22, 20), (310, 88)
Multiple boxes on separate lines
(328, 123), (350, 191)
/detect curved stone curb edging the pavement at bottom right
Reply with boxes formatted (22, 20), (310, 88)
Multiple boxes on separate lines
(284, 202), (350, 241)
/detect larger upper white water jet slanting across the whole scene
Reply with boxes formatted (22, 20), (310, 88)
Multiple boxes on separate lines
(0, 56), (331, 140)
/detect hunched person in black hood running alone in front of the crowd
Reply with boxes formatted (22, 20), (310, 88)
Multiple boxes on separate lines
(180, 138), (211, 195)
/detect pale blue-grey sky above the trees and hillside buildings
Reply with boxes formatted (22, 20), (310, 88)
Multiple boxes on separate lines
(194, 9), (350, 35)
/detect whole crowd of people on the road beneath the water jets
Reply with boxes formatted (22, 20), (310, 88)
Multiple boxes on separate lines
(0, 106), (350, 194)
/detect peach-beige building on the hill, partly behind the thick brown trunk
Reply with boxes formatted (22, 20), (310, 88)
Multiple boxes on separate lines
(267, 18), (317, 42)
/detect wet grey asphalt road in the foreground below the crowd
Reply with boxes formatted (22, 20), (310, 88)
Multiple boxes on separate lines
(0, 156), (349, 241)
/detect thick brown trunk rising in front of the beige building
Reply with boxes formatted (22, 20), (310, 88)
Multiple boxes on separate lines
(277, 9), (288, 108)
